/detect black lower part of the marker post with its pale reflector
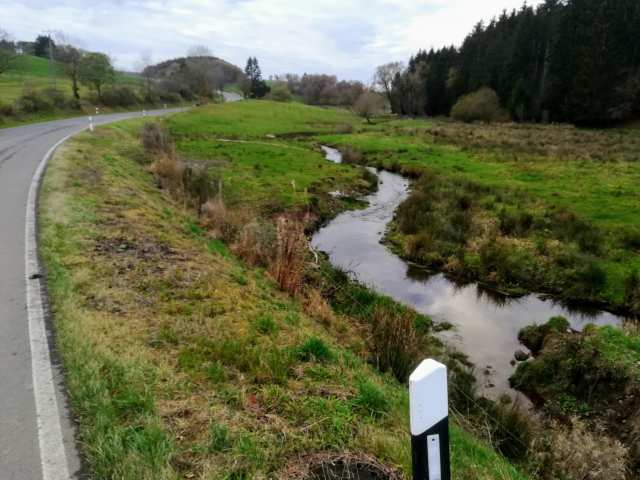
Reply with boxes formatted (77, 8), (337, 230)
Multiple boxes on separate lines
(411, 417), (451, 480)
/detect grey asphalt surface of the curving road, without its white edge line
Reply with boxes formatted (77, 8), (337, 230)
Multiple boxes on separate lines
(0, 107), (185, 480)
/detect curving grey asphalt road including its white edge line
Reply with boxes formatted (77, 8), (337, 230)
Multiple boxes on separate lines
(0, 107), (185, 480)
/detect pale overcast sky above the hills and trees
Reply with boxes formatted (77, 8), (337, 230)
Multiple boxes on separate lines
(0, 0), (540, 82)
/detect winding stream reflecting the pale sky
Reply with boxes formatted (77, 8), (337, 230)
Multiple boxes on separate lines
(312, 147), (623, 397)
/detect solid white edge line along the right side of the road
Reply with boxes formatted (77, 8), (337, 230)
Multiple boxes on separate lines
(25, 130), (81, 480)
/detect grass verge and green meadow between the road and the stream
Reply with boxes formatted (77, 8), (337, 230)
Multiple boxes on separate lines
(41, 102), (525, 480)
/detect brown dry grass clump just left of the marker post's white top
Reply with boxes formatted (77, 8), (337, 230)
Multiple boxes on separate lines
(370, 302), (421, 382)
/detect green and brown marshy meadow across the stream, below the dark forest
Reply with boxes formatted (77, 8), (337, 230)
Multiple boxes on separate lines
(320, 120), (640, 314)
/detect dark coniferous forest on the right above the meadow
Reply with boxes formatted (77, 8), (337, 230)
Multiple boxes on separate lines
(391, 0), (640, 125)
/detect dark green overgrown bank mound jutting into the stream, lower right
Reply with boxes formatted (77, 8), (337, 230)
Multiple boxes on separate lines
(510, 317), (640, 478)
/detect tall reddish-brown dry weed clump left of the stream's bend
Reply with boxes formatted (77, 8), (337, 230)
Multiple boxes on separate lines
(269, 217), (308, 295)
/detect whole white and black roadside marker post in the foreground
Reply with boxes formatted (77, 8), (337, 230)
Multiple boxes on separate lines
(409, 360), (451, 480)
